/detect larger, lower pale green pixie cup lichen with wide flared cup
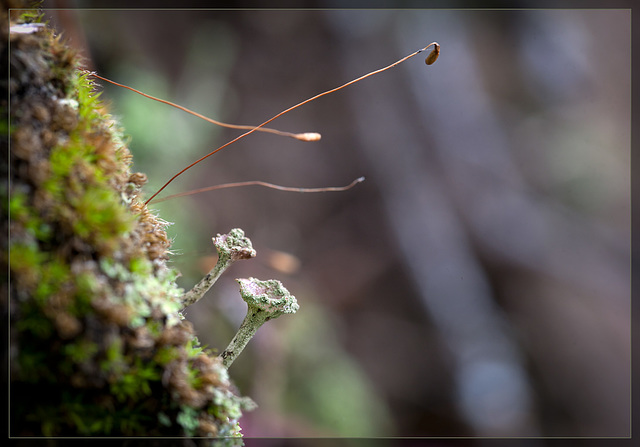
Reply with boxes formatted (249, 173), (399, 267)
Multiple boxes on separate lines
(220, 278), (300, 368)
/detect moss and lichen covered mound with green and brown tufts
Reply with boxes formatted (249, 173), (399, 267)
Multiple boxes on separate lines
(6, 11), (253, 437)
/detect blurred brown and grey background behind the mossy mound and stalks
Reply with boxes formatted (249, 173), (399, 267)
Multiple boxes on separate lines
(43, 1), (631, 437)
